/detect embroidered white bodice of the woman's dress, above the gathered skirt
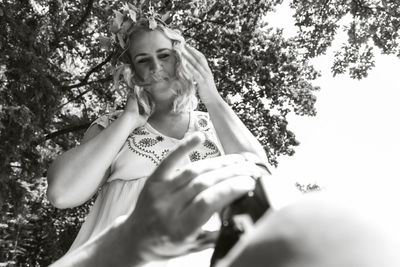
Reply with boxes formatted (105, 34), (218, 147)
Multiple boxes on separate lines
(93, 111), (222, 182)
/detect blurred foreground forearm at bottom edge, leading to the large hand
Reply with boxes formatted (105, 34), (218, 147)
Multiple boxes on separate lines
(51, 219), (144, 267)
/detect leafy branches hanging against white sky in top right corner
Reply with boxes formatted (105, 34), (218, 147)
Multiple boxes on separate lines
(291, 0), (400, 79)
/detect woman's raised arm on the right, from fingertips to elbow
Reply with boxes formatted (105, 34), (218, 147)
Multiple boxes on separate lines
(183, 46), (267, 162)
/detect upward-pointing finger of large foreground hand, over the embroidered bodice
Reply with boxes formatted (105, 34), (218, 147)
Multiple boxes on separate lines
(149, 133), (205, 181)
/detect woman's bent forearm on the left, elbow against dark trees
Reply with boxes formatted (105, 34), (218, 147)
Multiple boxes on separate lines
(48, 114), (140, 208)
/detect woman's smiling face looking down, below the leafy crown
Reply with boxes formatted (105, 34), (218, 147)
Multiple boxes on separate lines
(129, 30), (177, 93)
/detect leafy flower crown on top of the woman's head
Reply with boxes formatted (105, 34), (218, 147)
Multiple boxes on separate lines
(99, 3), (170, 51)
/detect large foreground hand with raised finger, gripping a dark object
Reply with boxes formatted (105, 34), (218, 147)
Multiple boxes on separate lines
(127, 135), (260, 262)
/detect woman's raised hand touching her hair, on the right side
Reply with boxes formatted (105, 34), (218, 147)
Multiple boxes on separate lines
(182, 45), (219, 104)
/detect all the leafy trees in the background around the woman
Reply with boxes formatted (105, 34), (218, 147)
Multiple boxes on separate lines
(0, 0), (399, 266)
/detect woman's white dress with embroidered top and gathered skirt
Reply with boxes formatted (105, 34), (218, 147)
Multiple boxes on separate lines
(67, 111), (223, 266)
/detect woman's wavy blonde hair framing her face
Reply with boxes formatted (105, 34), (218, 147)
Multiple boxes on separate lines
(114, 19), (198, 115)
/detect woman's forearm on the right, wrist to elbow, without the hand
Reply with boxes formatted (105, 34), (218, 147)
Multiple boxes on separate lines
(205, 95), (267, 162)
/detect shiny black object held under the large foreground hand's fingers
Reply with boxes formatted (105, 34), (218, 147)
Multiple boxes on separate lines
(211, 178), (271, 266)
